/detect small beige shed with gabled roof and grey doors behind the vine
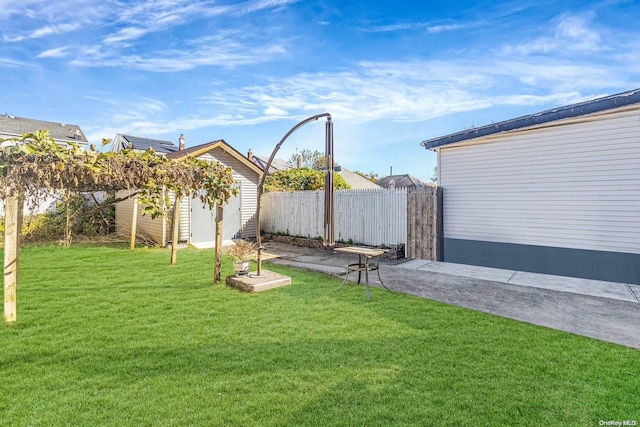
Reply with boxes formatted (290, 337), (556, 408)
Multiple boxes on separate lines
(116, 140), (262, 248)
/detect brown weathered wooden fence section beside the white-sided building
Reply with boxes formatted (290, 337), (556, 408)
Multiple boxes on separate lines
(406, 186), (443, 261)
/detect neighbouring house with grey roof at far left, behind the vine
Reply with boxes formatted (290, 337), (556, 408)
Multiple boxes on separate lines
(0, 114), (87, 216)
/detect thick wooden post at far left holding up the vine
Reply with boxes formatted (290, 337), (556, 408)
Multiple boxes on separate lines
(4, 194), (23, 322)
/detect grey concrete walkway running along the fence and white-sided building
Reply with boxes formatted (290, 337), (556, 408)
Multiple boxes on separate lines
(265, 242), (640, 349)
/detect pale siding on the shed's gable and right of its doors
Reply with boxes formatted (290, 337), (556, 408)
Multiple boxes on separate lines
(200, 148), (259, 239)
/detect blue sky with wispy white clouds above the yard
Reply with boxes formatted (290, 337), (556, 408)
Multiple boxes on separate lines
(0, 0), (640, 181)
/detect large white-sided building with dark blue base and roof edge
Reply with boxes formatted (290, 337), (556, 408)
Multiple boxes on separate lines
(421, 89), (640, 284)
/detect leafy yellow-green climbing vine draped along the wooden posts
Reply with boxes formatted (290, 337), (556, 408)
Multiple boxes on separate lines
(0, 130), (237, 217)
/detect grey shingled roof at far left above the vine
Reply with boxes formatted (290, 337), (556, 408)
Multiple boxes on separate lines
(0, 114), (88, 144)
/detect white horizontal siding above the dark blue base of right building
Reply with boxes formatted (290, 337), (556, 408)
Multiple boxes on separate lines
(439, 110), (640, 254)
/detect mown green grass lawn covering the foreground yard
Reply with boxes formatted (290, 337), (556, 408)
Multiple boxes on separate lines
(0, 246), (640, 426)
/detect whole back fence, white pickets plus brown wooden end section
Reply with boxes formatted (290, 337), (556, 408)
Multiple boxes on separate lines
(260, 187), (442, 260)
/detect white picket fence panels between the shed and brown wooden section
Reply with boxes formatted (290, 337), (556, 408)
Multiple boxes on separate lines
(260, 189), (407, 246)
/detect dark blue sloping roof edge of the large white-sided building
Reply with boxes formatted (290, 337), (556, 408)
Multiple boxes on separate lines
(420, 89), (640, 149)
